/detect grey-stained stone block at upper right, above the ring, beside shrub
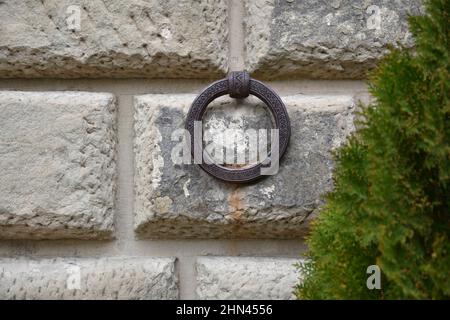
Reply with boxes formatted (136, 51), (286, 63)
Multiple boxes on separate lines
(244, 0), (422, 79)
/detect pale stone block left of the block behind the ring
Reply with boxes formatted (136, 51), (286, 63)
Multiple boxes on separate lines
(0, 91), (117, 239)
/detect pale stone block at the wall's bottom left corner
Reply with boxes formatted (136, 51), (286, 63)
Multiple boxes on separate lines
(0, 257), (178, 300)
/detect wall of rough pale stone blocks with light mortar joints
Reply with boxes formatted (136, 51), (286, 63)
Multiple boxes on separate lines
(0, 0), (421, 299)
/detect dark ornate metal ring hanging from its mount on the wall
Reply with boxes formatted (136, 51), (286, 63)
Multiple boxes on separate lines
(186, 71), (291, 183)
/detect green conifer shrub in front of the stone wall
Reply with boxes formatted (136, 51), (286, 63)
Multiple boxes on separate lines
(296, 0), (450, 299)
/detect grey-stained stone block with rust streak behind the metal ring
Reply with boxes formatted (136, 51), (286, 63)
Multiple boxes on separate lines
(134, 94), (354, 238)
